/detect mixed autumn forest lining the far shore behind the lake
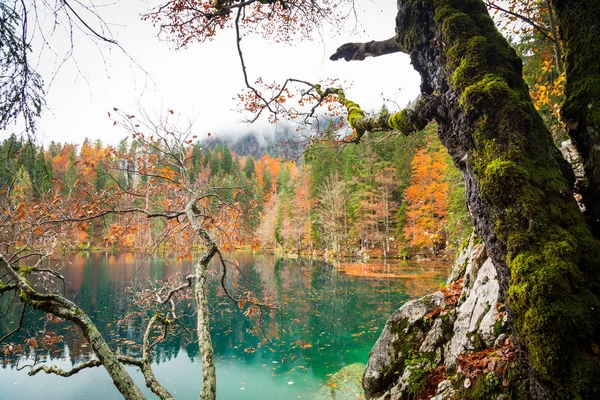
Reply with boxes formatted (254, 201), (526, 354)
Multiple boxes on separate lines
(0, 120), (472, 258)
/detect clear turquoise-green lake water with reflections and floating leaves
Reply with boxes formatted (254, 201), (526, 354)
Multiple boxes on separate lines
(0, 254), (447, 400)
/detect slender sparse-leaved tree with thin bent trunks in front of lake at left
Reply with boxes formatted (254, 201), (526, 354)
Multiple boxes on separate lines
(0, 111), (266, 399)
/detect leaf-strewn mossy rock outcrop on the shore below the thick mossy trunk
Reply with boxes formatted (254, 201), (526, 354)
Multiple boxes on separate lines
(362, 236), (526, 400)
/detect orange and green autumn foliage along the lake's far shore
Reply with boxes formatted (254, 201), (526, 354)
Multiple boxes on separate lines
(0, 116), (468, 258)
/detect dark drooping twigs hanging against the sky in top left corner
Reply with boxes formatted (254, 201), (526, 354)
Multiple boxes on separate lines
(0, 0), (145, 134)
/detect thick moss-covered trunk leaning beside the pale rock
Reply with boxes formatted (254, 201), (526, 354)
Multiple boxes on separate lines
(332, 0), (600, 398)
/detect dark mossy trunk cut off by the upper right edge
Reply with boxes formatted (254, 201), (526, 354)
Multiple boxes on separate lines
(553, 0), (600, 238)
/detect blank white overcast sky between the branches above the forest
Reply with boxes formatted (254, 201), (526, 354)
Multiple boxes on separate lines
(0, 0), (420, 144)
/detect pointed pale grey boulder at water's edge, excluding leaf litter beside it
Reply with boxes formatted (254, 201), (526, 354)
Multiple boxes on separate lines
(363, 233), (507, 400)
